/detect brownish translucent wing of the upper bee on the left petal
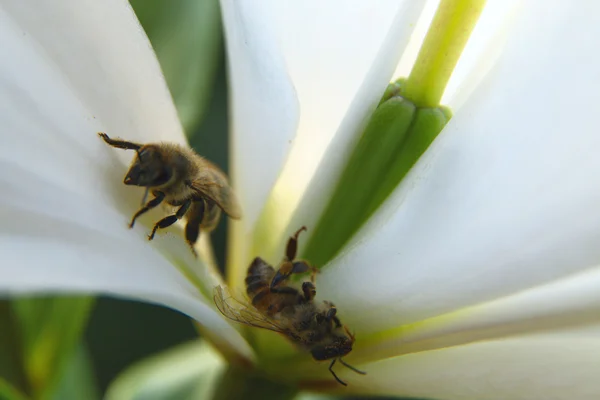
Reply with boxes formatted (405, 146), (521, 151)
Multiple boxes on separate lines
(190, 160), (242, 219)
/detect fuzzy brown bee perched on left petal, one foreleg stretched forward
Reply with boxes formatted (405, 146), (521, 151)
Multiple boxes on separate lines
(98, 132), (242, 255)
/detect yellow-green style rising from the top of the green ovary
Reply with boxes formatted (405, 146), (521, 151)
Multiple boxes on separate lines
(402, 0), (485, 107)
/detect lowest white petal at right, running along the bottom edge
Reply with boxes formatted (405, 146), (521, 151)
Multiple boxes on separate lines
(337, 327), (600, 400)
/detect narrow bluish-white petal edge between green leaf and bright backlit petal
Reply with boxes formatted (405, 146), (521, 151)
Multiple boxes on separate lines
(221, 0), (299, 227)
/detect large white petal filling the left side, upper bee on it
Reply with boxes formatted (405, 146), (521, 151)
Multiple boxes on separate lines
(0, 1), (251, 357)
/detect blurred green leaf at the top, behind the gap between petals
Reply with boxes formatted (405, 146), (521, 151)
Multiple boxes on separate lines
(131, 0), (222, 134)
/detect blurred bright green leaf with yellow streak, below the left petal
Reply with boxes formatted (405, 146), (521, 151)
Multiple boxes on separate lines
(11, 297), (94, 398)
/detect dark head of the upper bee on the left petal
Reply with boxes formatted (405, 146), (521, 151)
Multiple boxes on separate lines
(123, 145), (171, 187)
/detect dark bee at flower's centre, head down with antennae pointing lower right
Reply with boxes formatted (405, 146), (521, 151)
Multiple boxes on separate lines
(214, 227), (365, 386)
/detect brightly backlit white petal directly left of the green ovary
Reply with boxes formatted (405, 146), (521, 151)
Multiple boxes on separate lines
(258, 0), (425, 260)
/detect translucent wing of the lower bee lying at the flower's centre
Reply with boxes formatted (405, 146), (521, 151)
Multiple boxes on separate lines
(213, 286), (291, 335)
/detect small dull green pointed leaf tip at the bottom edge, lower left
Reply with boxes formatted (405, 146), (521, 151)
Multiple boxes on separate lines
(52, 344), (100, 400)
